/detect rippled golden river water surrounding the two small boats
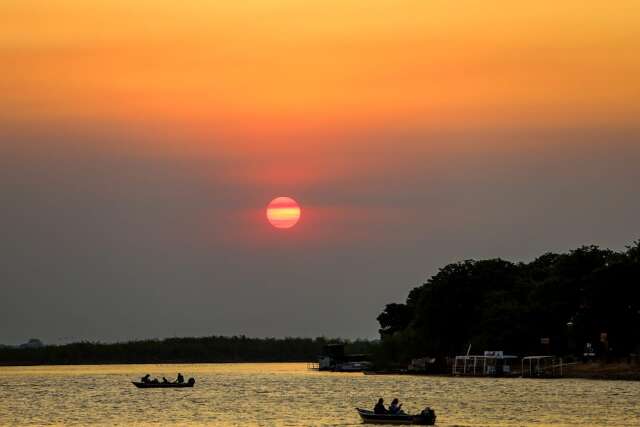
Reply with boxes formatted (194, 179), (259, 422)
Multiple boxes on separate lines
(0, 363), (640, 427)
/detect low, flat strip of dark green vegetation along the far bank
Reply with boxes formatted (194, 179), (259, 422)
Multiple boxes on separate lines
(0, 336), (375, 365)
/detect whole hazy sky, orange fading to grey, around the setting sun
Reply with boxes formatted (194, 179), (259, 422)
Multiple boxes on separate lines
(0, 0), (640, 343)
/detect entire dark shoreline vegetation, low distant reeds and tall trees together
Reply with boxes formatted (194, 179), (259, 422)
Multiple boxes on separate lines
(0, 241), (640, 380)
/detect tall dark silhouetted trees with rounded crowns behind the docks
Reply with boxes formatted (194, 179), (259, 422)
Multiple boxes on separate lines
(378, 241), (640, 363)
